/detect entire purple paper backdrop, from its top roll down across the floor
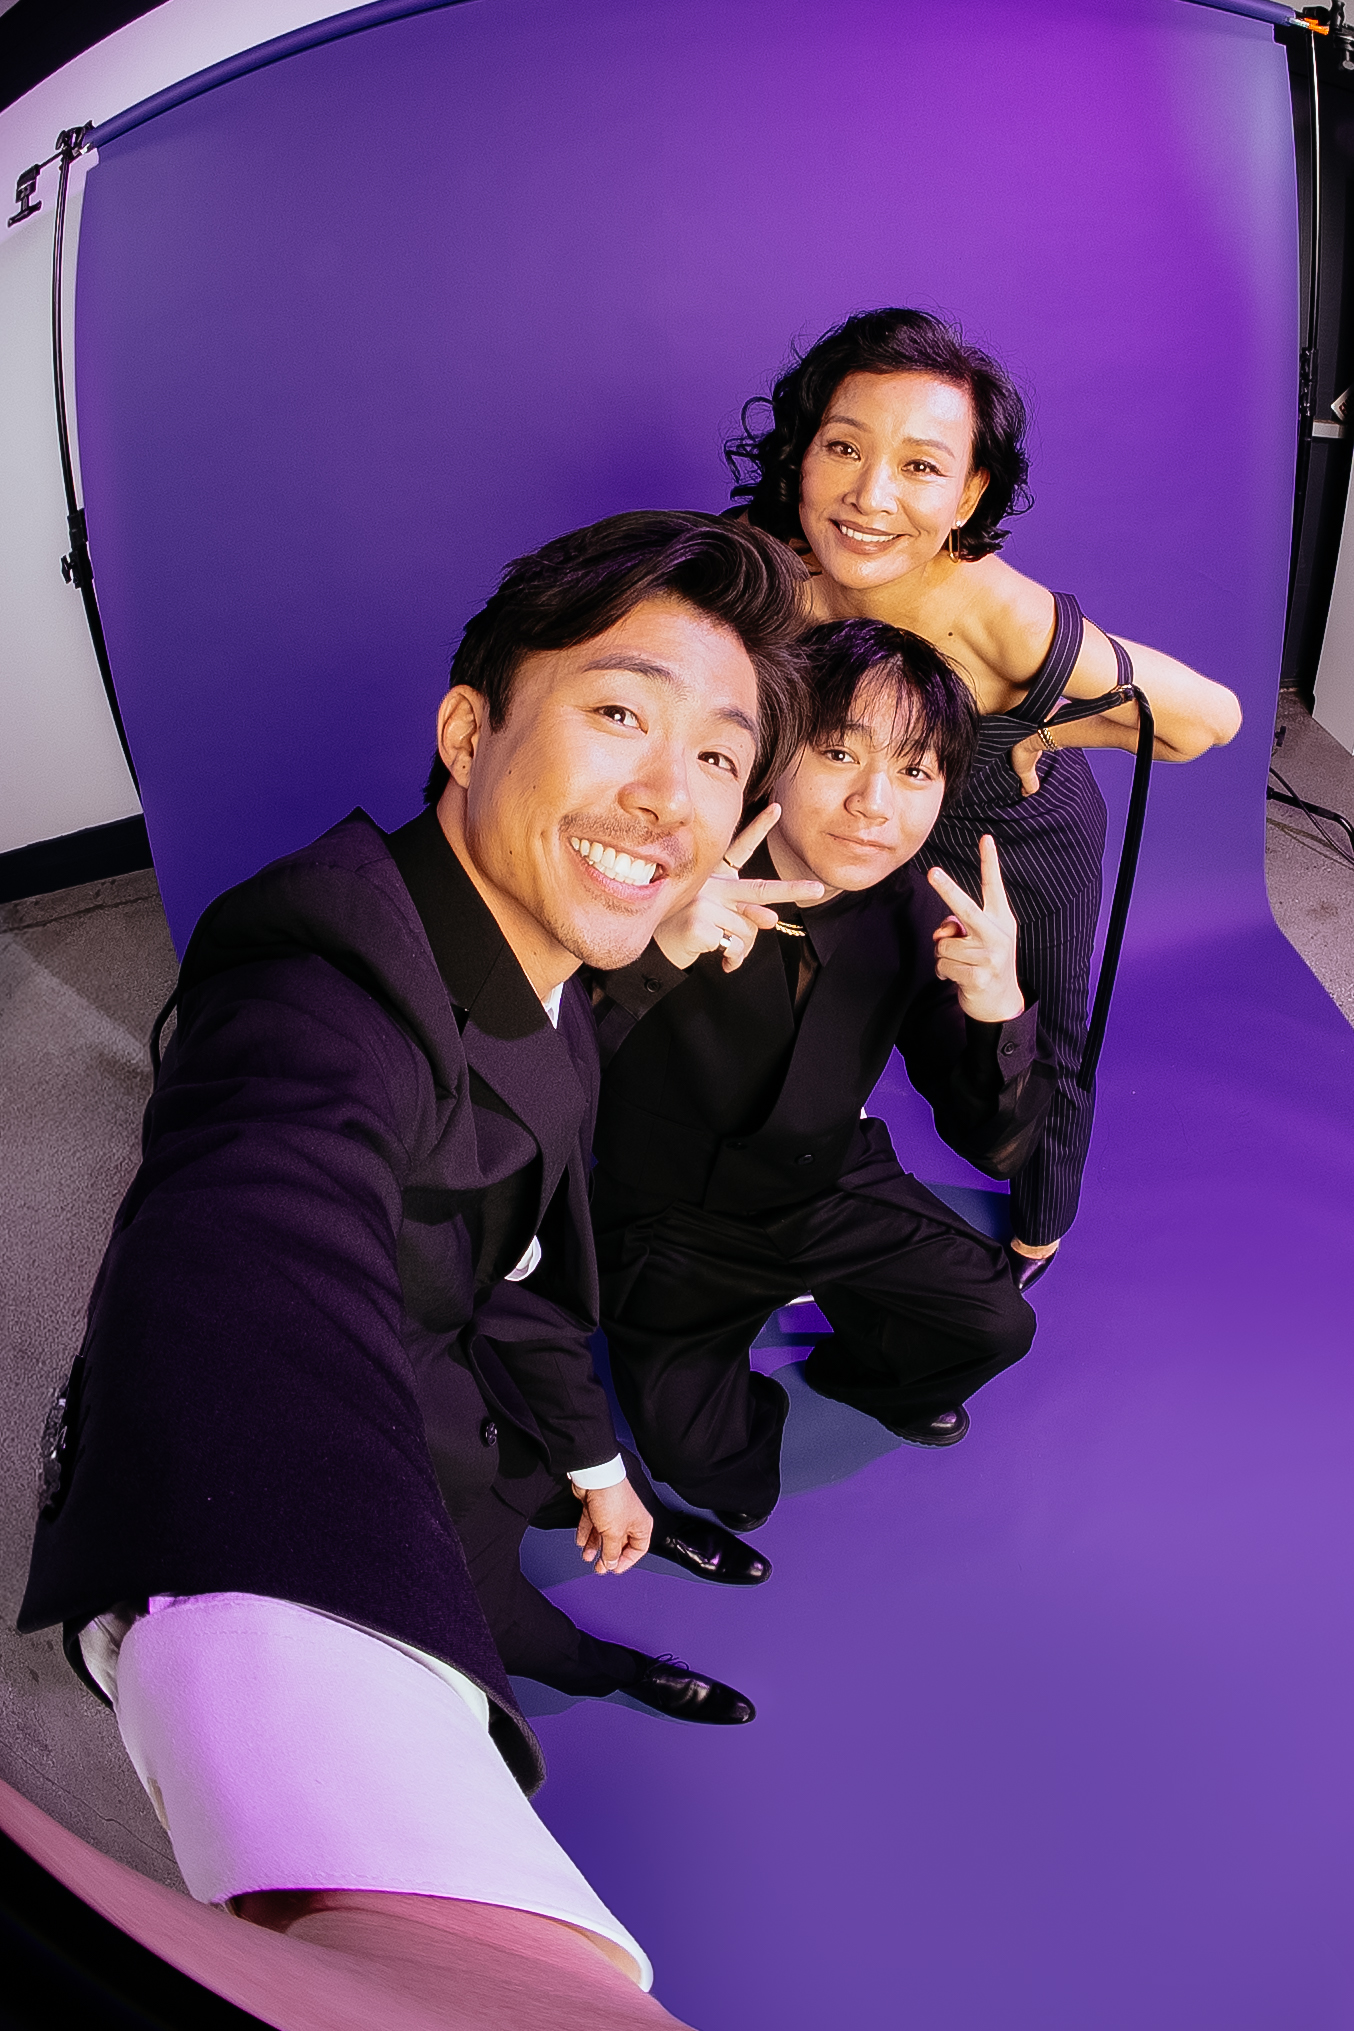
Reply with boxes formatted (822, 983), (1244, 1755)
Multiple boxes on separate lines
(77, 0), (1354, 2031)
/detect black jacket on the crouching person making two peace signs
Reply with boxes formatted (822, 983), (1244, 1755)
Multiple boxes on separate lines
(595, 847), (1054, 1215)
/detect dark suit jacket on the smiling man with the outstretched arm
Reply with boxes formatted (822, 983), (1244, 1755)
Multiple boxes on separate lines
(20, 812), (641, 1787)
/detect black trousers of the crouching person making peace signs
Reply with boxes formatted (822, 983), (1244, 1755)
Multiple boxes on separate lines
(593, 1160), (1035, 1515)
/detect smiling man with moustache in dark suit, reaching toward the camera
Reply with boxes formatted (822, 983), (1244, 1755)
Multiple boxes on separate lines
(20, 514), (816, 2021)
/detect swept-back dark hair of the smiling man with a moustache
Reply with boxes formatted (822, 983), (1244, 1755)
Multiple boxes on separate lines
(422, 510), (806, 804)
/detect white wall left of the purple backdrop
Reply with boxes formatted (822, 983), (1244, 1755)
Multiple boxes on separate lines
(0, 0), (373, 853)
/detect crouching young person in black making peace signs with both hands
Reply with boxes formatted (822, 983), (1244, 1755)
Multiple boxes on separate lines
(593, 619), (1050, 1529)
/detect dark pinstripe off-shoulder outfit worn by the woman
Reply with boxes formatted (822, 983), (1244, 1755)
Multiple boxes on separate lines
(918, 593), (1133, 1245)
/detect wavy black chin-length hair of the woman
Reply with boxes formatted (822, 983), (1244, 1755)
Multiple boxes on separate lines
(725, 311), (1029, 559)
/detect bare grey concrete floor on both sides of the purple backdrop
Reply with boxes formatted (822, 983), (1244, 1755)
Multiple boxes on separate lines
(0, 697), (1354, 1887)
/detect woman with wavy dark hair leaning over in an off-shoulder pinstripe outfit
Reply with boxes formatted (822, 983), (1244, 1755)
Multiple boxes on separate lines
(727, 309), (1240, 1288)
